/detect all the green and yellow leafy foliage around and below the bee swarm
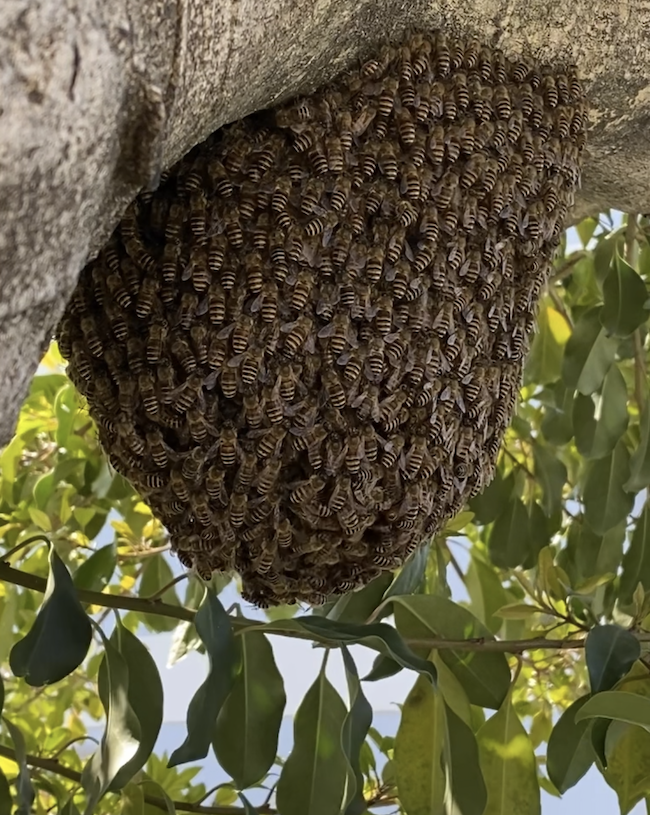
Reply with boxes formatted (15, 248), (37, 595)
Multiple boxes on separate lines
(0, 213), (650, 815)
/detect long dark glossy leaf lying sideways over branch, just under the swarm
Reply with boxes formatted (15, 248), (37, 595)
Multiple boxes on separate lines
(298, 616), (436, 683)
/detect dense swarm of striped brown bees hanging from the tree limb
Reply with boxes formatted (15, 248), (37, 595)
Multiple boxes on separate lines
(58, 33), (586, 605)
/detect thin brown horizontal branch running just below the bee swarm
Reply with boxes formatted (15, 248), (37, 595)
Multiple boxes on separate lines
(0, 562), (650, 654)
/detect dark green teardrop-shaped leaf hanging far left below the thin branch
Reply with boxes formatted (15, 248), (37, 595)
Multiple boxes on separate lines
(9, 546), (92, 687)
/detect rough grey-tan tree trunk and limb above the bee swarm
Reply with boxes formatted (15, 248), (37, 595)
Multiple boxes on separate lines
(0, 0), (650, 444)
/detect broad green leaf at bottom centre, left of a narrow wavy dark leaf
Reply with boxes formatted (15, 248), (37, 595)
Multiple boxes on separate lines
(277, 662), (348, 815)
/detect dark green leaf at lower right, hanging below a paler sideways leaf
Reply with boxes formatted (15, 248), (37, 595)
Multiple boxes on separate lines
(546, 694), (595, 793)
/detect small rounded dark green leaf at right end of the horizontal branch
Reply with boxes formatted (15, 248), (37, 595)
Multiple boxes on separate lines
(585, 625), (641, 694)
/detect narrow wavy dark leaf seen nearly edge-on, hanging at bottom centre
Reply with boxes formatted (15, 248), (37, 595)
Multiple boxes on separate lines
(341, 646), (372, 815)
